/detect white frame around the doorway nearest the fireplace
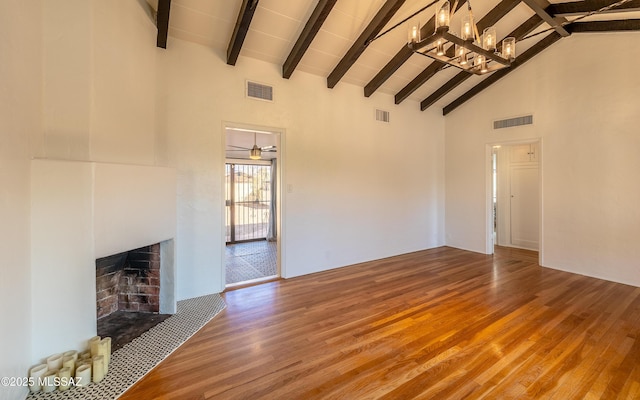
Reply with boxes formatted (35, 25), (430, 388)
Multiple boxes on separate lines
(220, 121), (287, 292)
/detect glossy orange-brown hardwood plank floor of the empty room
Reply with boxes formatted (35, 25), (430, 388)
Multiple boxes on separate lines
(121, 247), (640, 400)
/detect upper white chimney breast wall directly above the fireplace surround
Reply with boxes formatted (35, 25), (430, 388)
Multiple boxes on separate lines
(39, 0), (157, 165)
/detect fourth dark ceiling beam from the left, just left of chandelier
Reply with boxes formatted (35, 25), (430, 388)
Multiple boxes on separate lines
(327, 0), (405, 88)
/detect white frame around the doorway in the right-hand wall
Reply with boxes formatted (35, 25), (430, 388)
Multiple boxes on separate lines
(485, 137), (544, 265)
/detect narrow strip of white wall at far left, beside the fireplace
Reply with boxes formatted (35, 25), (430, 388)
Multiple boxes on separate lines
(0, 0), (42, 399)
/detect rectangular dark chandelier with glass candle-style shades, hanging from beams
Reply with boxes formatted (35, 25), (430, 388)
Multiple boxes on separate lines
(407, 0), (516, 75)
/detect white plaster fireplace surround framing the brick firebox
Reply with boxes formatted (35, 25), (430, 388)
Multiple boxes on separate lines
(31, 159), (176, 363)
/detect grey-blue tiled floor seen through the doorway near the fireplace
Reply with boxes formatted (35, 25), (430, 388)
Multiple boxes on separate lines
(225, 240), (277, 285)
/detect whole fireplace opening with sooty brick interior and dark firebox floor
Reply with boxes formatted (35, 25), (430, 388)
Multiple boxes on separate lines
(96, 243), (170, 351)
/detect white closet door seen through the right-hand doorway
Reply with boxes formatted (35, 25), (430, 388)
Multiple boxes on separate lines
(510, 166), (539, 250)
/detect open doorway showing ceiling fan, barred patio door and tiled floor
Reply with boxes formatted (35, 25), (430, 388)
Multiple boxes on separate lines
(224, 126), (281, 288)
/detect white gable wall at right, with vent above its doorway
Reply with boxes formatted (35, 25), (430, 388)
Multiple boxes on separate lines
(446, 33), (640, 286)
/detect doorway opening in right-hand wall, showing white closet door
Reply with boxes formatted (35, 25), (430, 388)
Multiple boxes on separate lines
(490, 142), (540, 251)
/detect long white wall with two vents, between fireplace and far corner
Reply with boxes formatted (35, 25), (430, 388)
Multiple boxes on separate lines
(157, 38), (444, 298)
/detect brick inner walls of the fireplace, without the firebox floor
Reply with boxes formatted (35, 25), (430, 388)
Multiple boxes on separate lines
(96, 243), (160, 319)
